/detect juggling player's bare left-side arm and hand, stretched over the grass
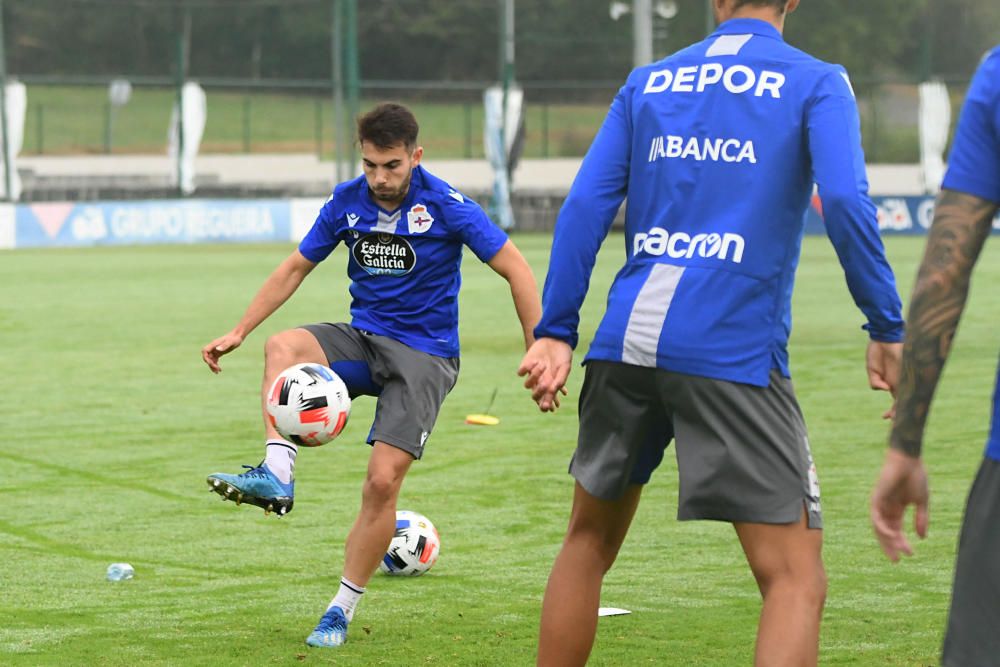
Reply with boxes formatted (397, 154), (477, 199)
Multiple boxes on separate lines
(207, 249), (316, 373)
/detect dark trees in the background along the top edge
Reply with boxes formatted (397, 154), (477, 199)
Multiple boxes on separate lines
(3, 0), (1000, 88)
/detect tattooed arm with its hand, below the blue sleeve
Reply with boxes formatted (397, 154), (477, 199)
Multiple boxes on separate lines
(871, 190), (997, 561)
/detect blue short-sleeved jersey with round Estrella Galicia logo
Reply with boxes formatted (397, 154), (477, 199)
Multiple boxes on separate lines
(299, 166), (507, 357)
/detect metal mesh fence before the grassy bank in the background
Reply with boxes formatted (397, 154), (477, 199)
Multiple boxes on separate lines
(13, 77), (968, 163)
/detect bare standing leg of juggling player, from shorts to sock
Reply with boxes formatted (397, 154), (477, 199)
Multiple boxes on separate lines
(344, 441), (413, 586)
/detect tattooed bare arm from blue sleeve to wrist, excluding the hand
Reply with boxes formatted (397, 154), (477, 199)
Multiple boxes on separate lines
(889, 190), (997, 456)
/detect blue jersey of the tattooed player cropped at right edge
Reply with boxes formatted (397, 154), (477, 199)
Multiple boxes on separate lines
(942, 47), (1000, 461)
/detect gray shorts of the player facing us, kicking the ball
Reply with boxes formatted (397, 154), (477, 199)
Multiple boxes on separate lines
(301, 322), (459, 459)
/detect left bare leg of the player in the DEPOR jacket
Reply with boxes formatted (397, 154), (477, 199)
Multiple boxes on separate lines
(538, 483), (642, 667)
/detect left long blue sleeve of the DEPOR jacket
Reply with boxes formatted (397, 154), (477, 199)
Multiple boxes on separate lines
(535, 88), (632, 348)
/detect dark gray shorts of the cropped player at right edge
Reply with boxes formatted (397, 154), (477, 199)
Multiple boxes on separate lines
(941, 457), (1000, 667)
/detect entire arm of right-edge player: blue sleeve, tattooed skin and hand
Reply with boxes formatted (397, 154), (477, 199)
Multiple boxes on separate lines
(871, 49), (1000, 561)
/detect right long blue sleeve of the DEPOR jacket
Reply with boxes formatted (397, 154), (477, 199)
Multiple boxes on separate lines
(806, 70), (903, 342)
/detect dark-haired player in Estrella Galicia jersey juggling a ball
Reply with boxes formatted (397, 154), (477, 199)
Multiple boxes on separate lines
(202, 104), (541, 646)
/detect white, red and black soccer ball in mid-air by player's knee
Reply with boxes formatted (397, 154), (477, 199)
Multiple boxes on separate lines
(267, 363), (351, 447)
